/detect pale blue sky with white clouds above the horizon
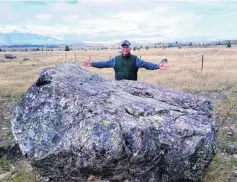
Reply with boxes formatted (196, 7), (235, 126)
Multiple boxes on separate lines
(0, 0), (237, 43)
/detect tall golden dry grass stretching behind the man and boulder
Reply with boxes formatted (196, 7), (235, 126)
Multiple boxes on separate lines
(0, 47), (237, 94)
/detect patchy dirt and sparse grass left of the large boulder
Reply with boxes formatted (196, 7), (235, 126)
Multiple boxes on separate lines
(0, 96), (34, 182)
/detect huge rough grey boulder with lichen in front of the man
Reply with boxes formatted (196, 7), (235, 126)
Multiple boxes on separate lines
(11, 63), (215, 182)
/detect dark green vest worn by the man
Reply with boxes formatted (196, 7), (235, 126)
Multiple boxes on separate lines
(114, 54), (138, 80)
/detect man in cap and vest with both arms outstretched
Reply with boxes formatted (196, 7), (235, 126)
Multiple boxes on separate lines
(83, 40), (168, 81)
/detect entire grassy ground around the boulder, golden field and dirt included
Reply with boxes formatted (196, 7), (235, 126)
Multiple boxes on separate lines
(0, 47), (237, 182)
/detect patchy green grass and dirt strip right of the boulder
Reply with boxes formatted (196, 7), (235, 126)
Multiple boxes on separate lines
(202, 92), (237, 182)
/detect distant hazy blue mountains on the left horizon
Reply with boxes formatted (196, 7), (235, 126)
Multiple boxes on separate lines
(0, 32), (84, 44)
